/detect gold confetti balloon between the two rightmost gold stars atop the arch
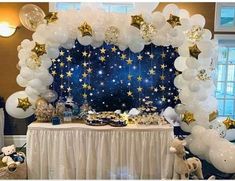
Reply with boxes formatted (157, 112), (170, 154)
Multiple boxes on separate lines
(140, 22), (157, 43)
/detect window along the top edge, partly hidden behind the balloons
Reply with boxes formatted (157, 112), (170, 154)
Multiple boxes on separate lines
(49, 2), (134, 13)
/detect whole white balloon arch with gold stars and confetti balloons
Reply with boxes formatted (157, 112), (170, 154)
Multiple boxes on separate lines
(6, 4), (235, 173)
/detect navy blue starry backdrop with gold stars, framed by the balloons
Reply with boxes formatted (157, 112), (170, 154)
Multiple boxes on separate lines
(50, 41), (179, 112)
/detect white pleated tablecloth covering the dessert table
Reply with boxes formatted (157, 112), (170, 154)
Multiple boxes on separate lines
(27, 123), (174, 179)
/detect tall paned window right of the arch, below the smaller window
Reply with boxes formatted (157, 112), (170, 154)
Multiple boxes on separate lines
(215, 35), (235, 118)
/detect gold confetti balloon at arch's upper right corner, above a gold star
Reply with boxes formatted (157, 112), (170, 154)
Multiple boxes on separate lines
(186, 25), (204, 42)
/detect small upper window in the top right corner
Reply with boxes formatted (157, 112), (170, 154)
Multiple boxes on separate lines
(214, 3), (235, 32)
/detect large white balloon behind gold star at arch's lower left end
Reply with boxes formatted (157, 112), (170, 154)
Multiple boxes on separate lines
(5, 91), (35, 119)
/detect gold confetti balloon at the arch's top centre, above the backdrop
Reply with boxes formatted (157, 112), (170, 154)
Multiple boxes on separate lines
(105, 26), (120, 45)
